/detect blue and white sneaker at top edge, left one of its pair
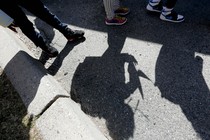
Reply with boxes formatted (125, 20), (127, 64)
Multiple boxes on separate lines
(146, 1), (163, 13)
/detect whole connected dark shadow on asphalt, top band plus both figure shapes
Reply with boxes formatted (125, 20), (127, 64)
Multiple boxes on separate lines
(31, 0), (210, 140)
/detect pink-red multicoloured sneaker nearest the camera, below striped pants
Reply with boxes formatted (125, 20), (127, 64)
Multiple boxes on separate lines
(105, 16), (127, 25)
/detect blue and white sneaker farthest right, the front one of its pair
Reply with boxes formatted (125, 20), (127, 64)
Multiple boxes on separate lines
(160, 10), (184, 23)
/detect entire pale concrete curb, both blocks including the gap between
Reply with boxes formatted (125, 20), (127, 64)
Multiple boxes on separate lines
(0, 27), (106, 140)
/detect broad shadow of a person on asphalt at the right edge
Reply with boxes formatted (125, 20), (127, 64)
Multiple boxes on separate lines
(155, 41), (210, 140)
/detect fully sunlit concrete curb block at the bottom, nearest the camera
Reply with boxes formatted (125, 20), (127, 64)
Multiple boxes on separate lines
(36, 98), (106, 140)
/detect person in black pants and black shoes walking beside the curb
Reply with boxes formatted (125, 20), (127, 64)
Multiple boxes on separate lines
(0, 0), (84, 57)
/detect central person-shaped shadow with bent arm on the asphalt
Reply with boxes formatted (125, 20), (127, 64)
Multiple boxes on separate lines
(70, 28), (148, 140)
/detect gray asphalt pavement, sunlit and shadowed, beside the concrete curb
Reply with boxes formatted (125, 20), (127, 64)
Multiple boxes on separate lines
(23, 0), (210, 140)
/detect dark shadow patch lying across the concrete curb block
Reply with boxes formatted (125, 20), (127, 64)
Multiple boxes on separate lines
(4, 51), (47, 111)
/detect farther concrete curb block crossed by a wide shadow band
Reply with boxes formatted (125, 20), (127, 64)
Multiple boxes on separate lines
(0, 27), (69, 115)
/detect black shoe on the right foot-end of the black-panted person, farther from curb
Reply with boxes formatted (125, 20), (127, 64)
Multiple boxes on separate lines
(63, 27), (85, 42)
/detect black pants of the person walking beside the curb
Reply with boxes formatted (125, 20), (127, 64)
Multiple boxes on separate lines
(0, 0), (66, 48)
